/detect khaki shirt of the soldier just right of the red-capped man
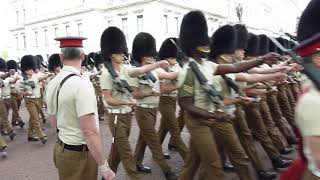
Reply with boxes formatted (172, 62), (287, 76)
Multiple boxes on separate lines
(100, 66), (132, 112)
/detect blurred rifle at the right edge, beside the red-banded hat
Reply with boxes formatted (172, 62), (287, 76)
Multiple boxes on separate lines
(269, 37), (320, 90)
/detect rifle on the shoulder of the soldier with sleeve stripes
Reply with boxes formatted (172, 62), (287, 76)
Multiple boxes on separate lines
(170, 39), (224, 111)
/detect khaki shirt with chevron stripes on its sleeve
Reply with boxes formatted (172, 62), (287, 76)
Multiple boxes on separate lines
(178, 58), (218, 111)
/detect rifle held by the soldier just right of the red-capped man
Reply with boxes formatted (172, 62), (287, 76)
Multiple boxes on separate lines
(105, 61), (133, 100)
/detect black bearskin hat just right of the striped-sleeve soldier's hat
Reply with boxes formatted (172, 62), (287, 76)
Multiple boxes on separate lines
(209, 25), (237, 59)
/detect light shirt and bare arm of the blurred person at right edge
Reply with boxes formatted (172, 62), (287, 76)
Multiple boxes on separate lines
(295, 82), (320, 177)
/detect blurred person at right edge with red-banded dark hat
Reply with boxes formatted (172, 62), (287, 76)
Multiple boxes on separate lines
(281, 0), (320, 180)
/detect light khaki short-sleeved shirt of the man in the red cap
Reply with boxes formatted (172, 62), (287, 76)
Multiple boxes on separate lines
(46, 66), (99, 145)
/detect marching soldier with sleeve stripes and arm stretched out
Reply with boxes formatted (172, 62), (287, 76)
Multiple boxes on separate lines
(178, 11), (284, 180)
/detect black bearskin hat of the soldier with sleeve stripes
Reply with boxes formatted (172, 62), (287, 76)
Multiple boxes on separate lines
(179, 11), (210, 57)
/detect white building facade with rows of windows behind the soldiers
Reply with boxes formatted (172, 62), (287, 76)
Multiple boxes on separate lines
(8, 0), (301, 61)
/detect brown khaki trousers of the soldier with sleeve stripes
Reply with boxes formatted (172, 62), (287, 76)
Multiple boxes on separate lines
(178, 113), (225, 180)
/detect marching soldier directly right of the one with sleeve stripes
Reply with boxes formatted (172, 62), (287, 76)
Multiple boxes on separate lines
(210, 25), (283, 179)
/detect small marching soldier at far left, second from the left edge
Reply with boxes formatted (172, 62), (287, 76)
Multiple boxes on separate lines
(7, 60), (25, 128)
